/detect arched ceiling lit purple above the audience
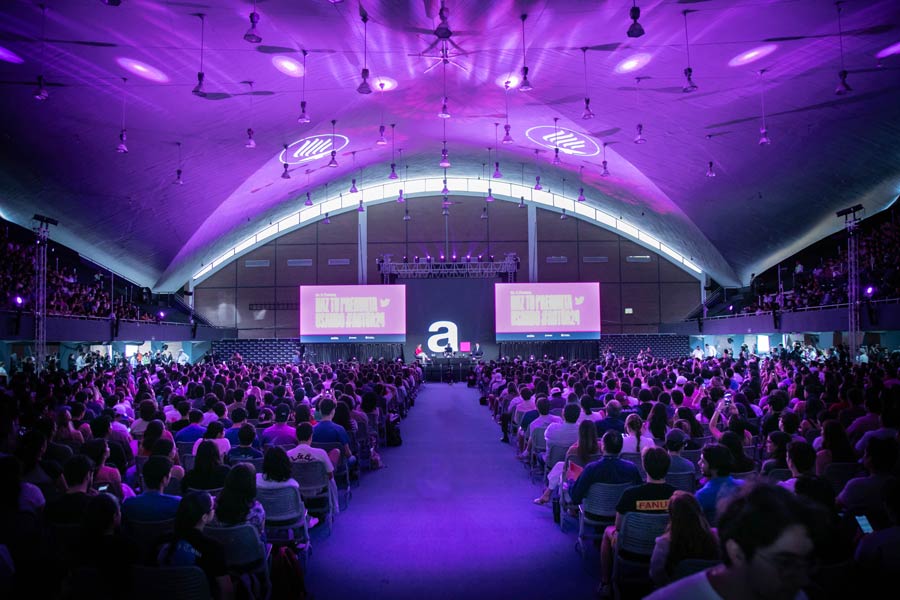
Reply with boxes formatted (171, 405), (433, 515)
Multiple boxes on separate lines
(0, 0), (900, 291)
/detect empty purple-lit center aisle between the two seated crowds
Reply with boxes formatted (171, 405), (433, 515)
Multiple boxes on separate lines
(307, 383), (598, 600)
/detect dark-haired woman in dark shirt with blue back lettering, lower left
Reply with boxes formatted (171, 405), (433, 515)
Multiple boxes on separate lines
(159, 492), (234, 600)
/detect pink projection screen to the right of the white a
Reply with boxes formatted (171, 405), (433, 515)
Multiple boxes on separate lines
(494, 281), (600, 342)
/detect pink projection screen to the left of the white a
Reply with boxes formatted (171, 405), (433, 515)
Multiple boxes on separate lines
(300, 285), (406, 344)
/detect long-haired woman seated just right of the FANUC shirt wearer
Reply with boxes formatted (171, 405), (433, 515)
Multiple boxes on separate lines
(650, 490), (719, 585)
